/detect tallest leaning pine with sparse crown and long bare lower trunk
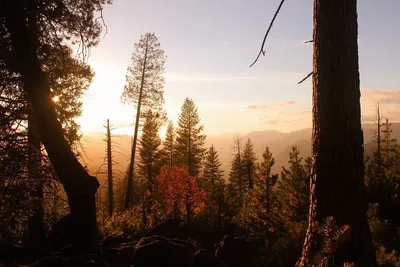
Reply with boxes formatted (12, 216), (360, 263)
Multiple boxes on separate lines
(121, 33), (166, 209)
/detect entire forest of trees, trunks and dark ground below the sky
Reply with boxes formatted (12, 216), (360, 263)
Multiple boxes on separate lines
(0, 0), (400, 267)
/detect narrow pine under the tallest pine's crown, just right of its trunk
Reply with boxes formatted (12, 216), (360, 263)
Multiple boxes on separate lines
(138, 110), (161, 225)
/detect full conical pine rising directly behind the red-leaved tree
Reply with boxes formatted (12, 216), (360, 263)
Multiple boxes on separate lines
(176, 98), (206, 177)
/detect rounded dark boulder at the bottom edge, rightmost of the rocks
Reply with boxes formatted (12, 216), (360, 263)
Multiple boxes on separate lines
(215, 235), (256, 267)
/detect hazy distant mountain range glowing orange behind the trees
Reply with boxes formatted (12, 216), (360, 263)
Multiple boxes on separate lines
(82, 123), (400, 186)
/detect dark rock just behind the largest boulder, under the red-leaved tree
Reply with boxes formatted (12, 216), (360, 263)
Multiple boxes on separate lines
(146, 219), (188, 239)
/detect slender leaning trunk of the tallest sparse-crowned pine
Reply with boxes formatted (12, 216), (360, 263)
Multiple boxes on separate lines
(124, 40), (149, 210)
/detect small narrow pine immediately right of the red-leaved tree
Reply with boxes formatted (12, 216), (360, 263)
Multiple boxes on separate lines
(203, 145), (225, 226)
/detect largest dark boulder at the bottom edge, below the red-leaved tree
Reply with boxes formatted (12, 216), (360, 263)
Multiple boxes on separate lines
(132, 236), (194, 267)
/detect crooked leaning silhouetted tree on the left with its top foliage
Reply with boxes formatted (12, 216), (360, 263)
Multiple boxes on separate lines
(0, 0), (111, 252)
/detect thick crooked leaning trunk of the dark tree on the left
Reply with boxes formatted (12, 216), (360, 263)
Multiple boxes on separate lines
(3, 0), (100, 253)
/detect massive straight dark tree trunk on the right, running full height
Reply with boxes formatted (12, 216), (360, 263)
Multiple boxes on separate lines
(297, 0), (376, 266)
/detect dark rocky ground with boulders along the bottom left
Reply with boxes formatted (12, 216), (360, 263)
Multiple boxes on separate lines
(0, 217), (259, 267)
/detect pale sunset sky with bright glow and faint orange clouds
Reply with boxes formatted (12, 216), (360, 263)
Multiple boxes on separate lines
(79, 0), (400, 134)
